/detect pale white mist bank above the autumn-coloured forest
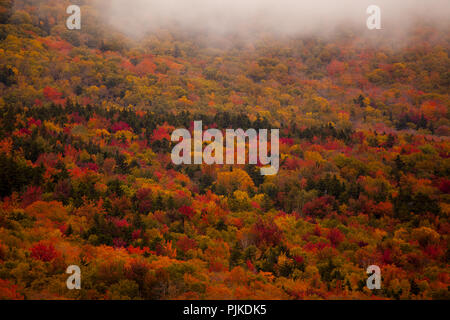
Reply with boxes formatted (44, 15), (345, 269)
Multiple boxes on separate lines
(96, 0), (450, 36)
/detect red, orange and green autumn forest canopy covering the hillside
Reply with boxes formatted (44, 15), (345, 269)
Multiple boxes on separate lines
(0, 0), (450, 299)
